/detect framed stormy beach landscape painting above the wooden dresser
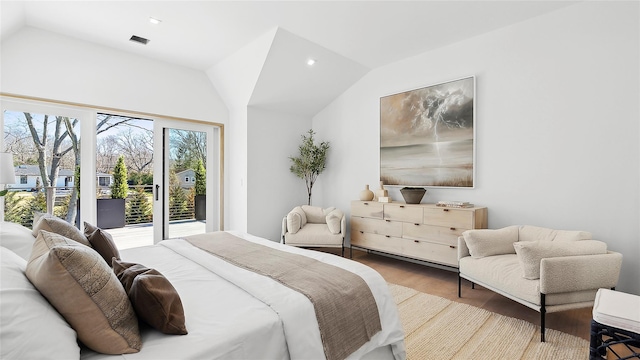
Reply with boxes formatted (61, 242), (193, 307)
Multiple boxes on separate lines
(380, 76), (475, 188)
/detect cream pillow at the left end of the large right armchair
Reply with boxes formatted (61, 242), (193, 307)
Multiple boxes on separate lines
(462, 226), (518, 259)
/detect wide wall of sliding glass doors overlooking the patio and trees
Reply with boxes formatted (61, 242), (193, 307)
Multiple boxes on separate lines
(0, 97), (223, 248)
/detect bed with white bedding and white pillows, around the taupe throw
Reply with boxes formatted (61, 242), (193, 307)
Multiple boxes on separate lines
(0, 222), (406, 360)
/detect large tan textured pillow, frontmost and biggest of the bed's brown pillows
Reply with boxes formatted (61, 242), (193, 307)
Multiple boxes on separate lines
(26, 230), (142, 354)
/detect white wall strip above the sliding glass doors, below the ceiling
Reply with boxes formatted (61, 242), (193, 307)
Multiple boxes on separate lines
(0, 27), (227, 123)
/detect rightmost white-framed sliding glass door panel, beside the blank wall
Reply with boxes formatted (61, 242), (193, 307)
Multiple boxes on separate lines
(153, 120), (221, 242)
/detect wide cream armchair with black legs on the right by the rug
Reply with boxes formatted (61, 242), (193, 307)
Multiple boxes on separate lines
(458, 225), (622, 342)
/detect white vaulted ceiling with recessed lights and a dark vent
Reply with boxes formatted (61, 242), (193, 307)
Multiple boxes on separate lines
(0, 1), (575, 115)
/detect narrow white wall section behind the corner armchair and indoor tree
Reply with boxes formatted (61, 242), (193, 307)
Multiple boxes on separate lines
(247, 107), (315, 241)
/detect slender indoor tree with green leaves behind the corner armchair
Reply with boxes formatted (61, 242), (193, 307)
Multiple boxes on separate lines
(289, 129), (329, 205)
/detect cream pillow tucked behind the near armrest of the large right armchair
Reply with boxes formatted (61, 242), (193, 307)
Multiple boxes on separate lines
(513, 240), (607, 279)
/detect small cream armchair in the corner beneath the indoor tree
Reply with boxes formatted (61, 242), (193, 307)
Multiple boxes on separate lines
(282, 205), (346, 256)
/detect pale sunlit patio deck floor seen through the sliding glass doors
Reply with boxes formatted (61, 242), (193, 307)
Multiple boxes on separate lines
(106, 220), (205, 250)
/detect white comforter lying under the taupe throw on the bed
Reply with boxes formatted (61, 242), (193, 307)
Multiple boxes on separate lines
(82, 231), (405, 360)
